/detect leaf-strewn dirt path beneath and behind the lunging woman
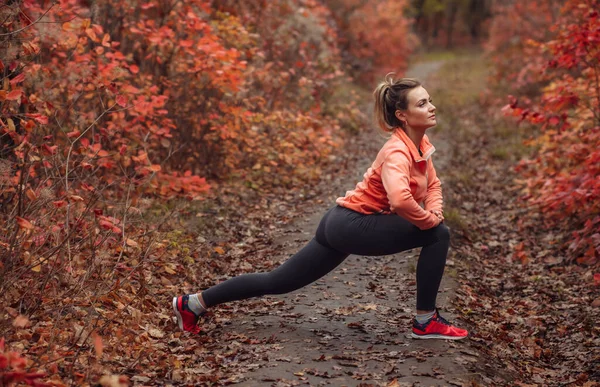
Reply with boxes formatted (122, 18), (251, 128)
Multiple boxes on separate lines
(199, 62), (476, 386)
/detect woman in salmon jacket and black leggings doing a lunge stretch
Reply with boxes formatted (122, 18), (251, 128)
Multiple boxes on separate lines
(173, 74), (467, 340)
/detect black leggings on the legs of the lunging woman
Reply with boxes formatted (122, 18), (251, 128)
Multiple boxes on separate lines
(202, 206), (450, 310)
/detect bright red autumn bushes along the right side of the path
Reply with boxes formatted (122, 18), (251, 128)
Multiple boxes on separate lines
(490, 0), (600, 264)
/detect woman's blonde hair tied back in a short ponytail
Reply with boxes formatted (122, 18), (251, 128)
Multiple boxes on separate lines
(373, 73), (421, 132)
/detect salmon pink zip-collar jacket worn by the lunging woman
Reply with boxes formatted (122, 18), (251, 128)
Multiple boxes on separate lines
(336, 128), (442, 230)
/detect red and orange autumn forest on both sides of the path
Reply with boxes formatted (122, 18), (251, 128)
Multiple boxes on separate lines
(0, 0), (600, 384)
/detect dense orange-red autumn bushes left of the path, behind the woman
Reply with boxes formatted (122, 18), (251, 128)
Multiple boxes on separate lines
(0, 0), (360, 280)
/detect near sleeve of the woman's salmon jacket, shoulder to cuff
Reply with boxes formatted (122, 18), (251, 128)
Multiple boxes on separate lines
(381, 150), (439, 230)
